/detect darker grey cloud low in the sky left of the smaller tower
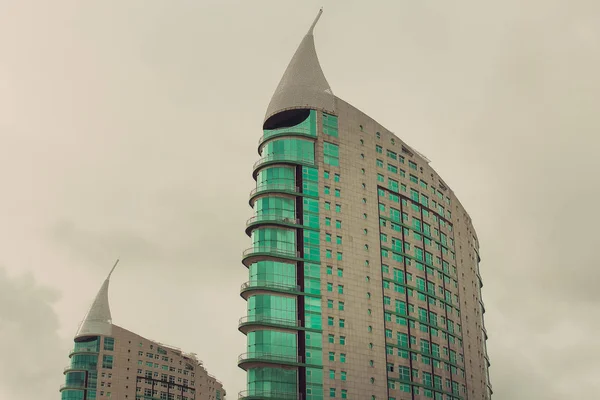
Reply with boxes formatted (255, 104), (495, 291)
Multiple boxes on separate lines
(0, 268), (68, 400)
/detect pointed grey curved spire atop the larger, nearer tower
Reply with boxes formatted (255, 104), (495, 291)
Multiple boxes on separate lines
(265, 9), (335, 121)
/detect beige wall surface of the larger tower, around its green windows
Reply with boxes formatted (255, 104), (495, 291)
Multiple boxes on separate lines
(315, 99), (491, 400)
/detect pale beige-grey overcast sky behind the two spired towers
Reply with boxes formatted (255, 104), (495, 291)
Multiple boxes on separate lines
(0, 0), (600, 400)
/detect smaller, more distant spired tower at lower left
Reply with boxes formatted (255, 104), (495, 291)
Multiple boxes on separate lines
(60, 264), (226, 400)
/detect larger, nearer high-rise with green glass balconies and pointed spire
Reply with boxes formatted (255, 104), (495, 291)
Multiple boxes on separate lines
(238, 12), (492, 400)
